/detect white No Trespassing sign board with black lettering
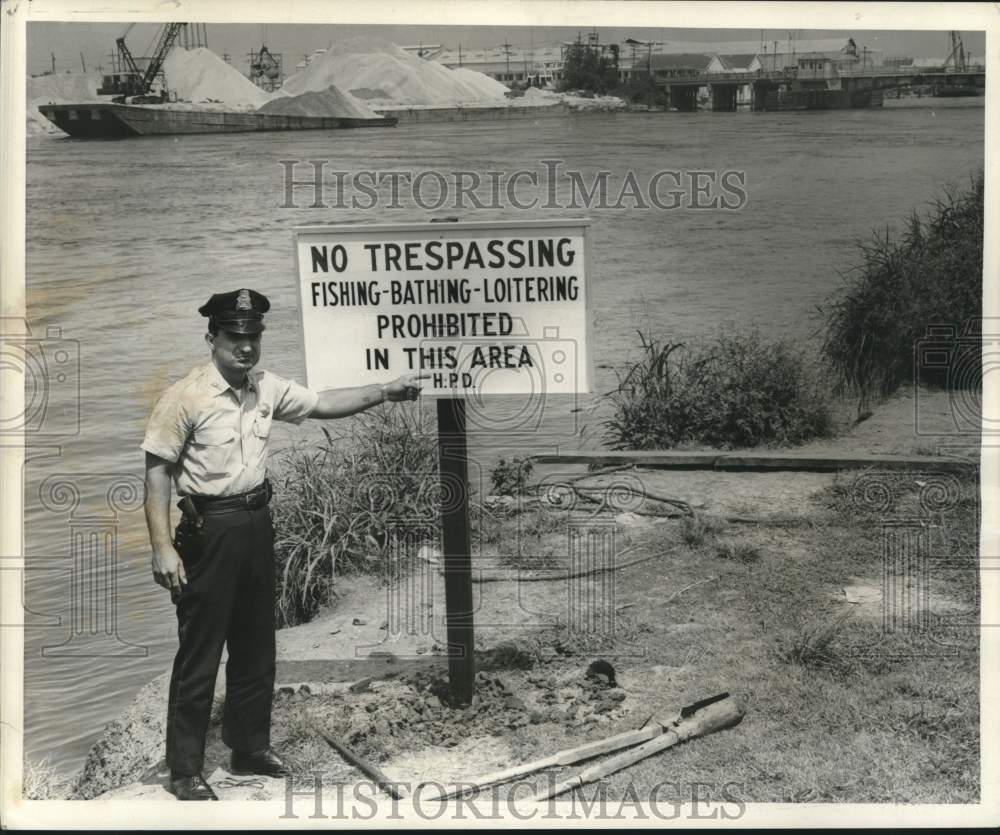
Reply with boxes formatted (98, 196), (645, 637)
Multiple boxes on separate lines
(295, 220), (593, 396)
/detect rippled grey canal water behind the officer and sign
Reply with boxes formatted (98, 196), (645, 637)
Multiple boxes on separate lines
(24, 99), (983, 773)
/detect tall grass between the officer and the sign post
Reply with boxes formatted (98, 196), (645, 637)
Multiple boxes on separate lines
(271, 407), (439, 626)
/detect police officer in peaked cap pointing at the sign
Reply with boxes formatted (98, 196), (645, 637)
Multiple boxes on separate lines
(142, 289), (426, 800)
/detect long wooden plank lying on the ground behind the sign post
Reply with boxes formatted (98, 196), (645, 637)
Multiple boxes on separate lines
(529, 450), (978, 473)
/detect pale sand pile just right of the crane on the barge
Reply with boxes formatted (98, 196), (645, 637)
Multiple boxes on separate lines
(163, 47), (274, 109)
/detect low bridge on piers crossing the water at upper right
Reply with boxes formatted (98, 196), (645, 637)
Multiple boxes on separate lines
(656, 66), (986, 112)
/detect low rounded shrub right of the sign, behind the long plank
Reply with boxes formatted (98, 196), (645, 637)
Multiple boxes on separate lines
(604, 328), (833, 449)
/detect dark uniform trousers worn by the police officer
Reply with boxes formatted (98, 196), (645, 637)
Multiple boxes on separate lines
(167, 505), (275, 775)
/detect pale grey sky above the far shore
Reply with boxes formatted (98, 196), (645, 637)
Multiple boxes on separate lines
(27, 22), (985, 74)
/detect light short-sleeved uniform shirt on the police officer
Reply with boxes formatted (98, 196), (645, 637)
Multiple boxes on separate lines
(142, 362), (319, 496)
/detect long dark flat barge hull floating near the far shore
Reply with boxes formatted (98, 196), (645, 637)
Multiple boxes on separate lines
(38, 102), (397, 139)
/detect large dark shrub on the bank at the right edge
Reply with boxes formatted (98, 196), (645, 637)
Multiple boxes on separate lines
(818, 173), (983, 413)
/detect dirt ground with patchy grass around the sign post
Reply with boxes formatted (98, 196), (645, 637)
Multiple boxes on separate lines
(86, 390), (979, 803)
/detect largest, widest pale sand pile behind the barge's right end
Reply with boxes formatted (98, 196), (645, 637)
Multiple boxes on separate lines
(284, 37), (507, 106)
